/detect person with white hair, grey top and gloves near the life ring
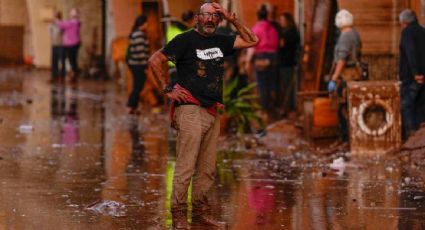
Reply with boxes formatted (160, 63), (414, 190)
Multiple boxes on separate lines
(328, 10), (362, 142)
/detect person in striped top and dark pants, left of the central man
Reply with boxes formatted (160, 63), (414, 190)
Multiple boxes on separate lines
(127, 15), (149, 114)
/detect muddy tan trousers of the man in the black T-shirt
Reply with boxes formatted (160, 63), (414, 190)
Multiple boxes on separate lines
(171, 105), (220, 212)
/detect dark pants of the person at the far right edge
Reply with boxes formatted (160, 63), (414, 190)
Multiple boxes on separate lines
(400, 82), (424, 138)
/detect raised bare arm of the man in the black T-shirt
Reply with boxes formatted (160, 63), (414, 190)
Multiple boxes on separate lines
(212, 3), (258, 49)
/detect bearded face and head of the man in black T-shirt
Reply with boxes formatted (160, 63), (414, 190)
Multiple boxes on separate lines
(195, 4), (221, 36)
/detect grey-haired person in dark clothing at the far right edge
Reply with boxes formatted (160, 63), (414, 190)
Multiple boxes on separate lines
(399, 9), (425, 138)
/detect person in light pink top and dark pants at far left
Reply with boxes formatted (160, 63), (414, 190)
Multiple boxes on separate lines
(58, 8), (81, 81)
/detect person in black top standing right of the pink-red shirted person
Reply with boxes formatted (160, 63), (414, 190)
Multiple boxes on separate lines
(277, 13), (300, 117)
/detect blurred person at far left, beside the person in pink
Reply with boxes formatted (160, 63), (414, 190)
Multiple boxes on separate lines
(49, 11), (65, 83)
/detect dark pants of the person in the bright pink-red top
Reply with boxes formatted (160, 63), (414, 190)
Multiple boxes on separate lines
(254, 53), (277, 110)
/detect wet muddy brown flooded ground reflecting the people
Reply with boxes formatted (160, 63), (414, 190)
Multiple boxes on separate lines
(0, 68), (425, 230)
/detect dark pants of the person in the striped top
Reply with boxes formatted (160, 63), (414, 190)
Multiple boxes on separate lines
(127, 65), (146, 109)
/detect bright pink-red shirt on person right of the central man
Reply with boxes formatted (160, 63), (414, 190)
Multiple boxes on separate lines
(252, 21), (279, 54)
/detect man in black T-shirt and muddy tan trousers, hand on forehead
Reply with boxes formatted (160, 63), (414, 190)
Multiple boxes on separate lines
(149, 2), (258, 229)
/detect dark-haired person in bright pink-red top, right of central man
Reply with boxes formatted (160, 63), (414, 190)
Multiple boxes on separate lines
(247, 5), (279, 121)
